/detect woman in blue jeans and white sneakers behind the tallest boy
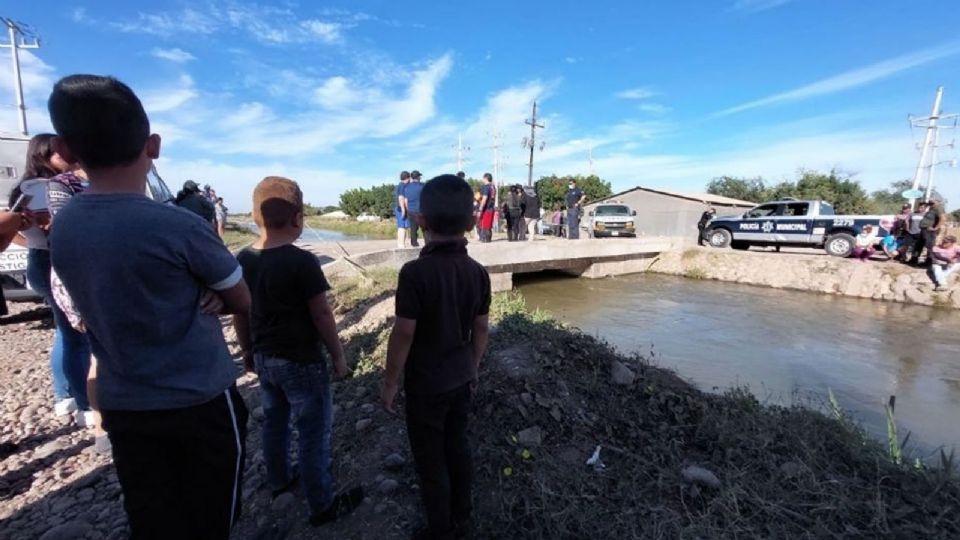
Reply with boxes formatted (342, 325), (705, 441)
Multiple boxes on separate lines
(11, 134), (92, 425)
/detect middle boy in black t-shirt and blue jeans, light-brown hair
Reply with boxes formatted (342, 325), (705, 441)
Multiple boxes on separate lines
(234, 176), (363, 526)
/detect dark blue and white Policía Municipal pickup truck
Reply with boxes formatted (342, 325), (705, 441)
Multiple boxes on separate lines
(704, 199), (893, 257)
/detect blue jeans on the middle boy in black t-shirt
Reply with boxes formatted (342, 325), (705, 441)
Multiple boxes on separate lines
(254, 354), (333, 514)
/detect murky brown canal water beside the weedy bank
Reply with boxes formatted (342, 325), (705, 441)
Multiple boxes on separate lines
(517, 274), (960, 457)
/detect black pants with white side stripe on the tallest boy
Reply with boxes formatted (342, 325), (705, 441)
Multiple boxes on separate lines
(101, 386), (247, 540)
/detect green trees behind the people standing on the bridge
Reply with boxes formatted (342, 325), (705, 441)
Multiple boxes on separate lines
(340, 175), (613, 218)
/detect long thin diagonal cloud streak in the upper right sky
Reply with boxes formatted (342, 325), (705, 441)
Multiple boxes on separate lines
(712, 41), (960, 117)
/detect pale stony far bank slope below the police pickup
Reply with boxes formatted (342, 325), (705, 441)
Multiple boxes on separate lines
(647, 248), (960, 309)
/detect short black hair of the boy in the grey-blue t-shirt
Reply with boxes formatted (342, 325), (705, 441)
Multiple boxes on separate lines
(47, 75), (150, 169)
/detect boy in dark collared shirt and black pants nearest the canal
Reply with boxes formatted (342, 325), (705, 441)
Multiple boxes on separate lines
(381, 175), (490, 539)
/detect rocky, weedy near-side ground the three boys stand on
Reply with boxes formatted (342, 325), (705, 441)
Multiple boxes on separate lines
(0, 275), (960, 540)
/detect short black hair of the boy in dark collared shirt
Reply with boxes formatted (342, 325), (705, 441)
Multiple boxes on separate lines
(420, 174), (473, 235)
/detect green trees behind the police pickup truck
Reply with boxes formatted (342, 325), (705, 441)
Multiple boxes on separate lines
(707, 169), (960, 219)
